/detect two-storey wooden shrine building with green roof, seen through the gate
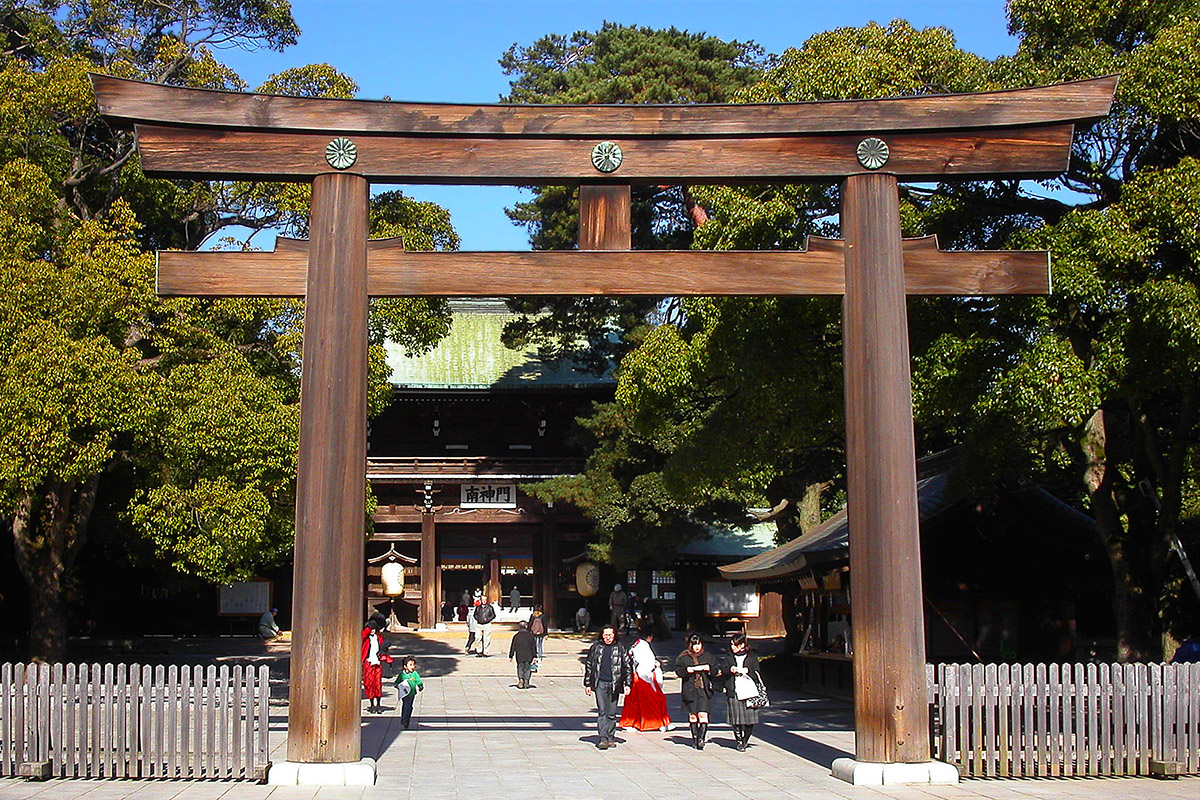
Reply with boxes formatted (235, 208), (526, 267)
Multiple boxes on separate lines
(365, 300), (616, 627)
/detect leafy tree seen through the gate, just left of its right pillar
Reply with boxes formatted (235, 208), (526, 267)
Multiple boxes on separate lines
(545, 22), (986, 566)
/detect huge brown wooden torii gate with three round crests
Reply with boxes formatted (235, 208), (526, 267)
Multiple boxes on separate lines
(92, 76), (1116, 783)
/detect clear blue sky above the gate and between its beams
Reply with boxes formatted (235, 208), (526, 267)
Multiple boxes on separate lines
(213, 0), (1016, 249)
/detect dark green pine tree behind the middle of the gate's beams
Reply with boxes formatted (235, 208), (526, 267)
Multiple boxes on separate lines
(500, 23), (769, 372)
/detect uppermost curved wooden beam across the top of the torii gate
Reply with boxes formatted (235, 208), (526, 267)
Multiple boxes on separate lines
(91, 74), (1117, 139)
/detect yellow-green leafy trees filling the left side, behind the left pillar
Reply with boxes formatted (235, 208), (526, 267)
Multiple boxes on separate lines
(0, 0), (458, 658)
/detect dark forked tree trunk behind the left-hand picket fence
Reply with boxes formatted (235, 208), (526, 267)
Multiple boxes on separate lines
(12, 475), (100, 662)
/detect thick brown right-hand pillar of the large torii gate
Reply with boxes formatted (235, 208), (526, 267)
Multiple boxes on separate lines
(841, 173), (930, 763)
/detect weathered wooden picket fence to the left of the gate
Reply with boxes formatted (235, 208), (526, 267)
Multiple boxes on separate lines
(0, 663), (270, 780)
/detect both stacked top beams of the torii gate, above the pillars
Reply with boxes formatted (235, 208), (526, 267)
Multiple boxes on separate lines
(92, 76), (1116, 185)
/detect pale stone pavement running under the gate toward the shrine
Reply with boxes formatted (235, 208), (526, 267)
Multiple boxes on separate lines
(0, 631), (1200, 800)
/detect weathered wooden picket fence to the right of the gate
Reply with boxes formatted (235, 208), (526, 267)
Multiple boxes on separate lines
(926, 663), (1200, 777)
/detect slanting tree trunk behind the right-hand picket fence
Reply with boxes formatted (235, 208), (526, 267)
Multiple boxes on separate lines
(1080, 408), (1153, 662)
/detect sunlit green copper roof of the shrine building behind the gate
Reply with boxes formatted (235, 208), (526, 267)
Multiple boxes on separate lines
(385, 300), (613, 389)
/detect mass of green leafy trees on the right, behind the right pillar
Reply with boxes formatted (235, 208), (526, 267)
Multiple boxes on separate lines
(540, 7), (1200, 660)
